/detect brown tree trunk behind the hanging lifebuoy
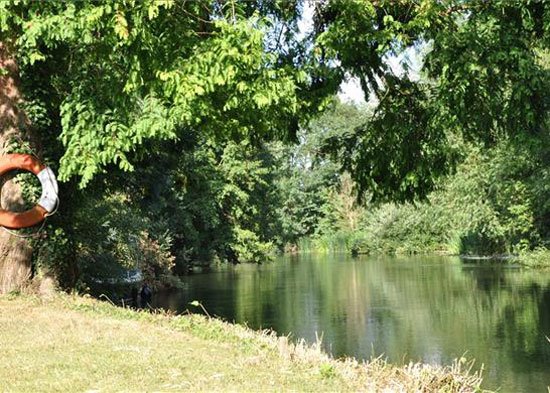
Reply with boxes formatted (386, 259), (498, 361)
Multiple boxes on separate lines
(0, 42), (32, 293)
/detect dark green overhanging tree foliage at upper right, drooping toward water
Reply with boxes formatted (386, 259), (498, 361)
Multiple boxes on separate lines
(313, 0), (550, 200)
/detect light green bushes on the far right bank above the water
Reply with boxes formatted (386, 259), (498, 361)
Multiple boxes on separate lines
(338, 141), (550, 255)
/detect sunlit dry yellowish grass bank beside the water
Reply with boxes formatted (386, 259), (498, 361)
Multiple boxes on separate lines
(0, 294), (492, 392)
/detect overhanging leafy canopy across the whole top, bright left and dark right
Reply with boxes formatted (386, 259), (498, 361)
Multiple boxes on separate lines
(4, 0), (549, 199)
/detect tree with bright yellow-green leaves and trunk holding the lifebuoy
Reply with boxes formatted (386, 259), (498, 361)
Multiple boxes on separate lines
(0, 0), (314, 290)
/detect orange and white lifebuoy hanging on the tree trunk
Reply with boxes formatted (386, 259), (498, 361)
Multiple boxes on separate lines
(0, 154), (59, 229)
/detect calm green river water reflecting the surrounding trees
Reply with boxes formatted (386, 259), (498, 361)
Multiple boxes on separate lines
(153, 255), (550, 393)
